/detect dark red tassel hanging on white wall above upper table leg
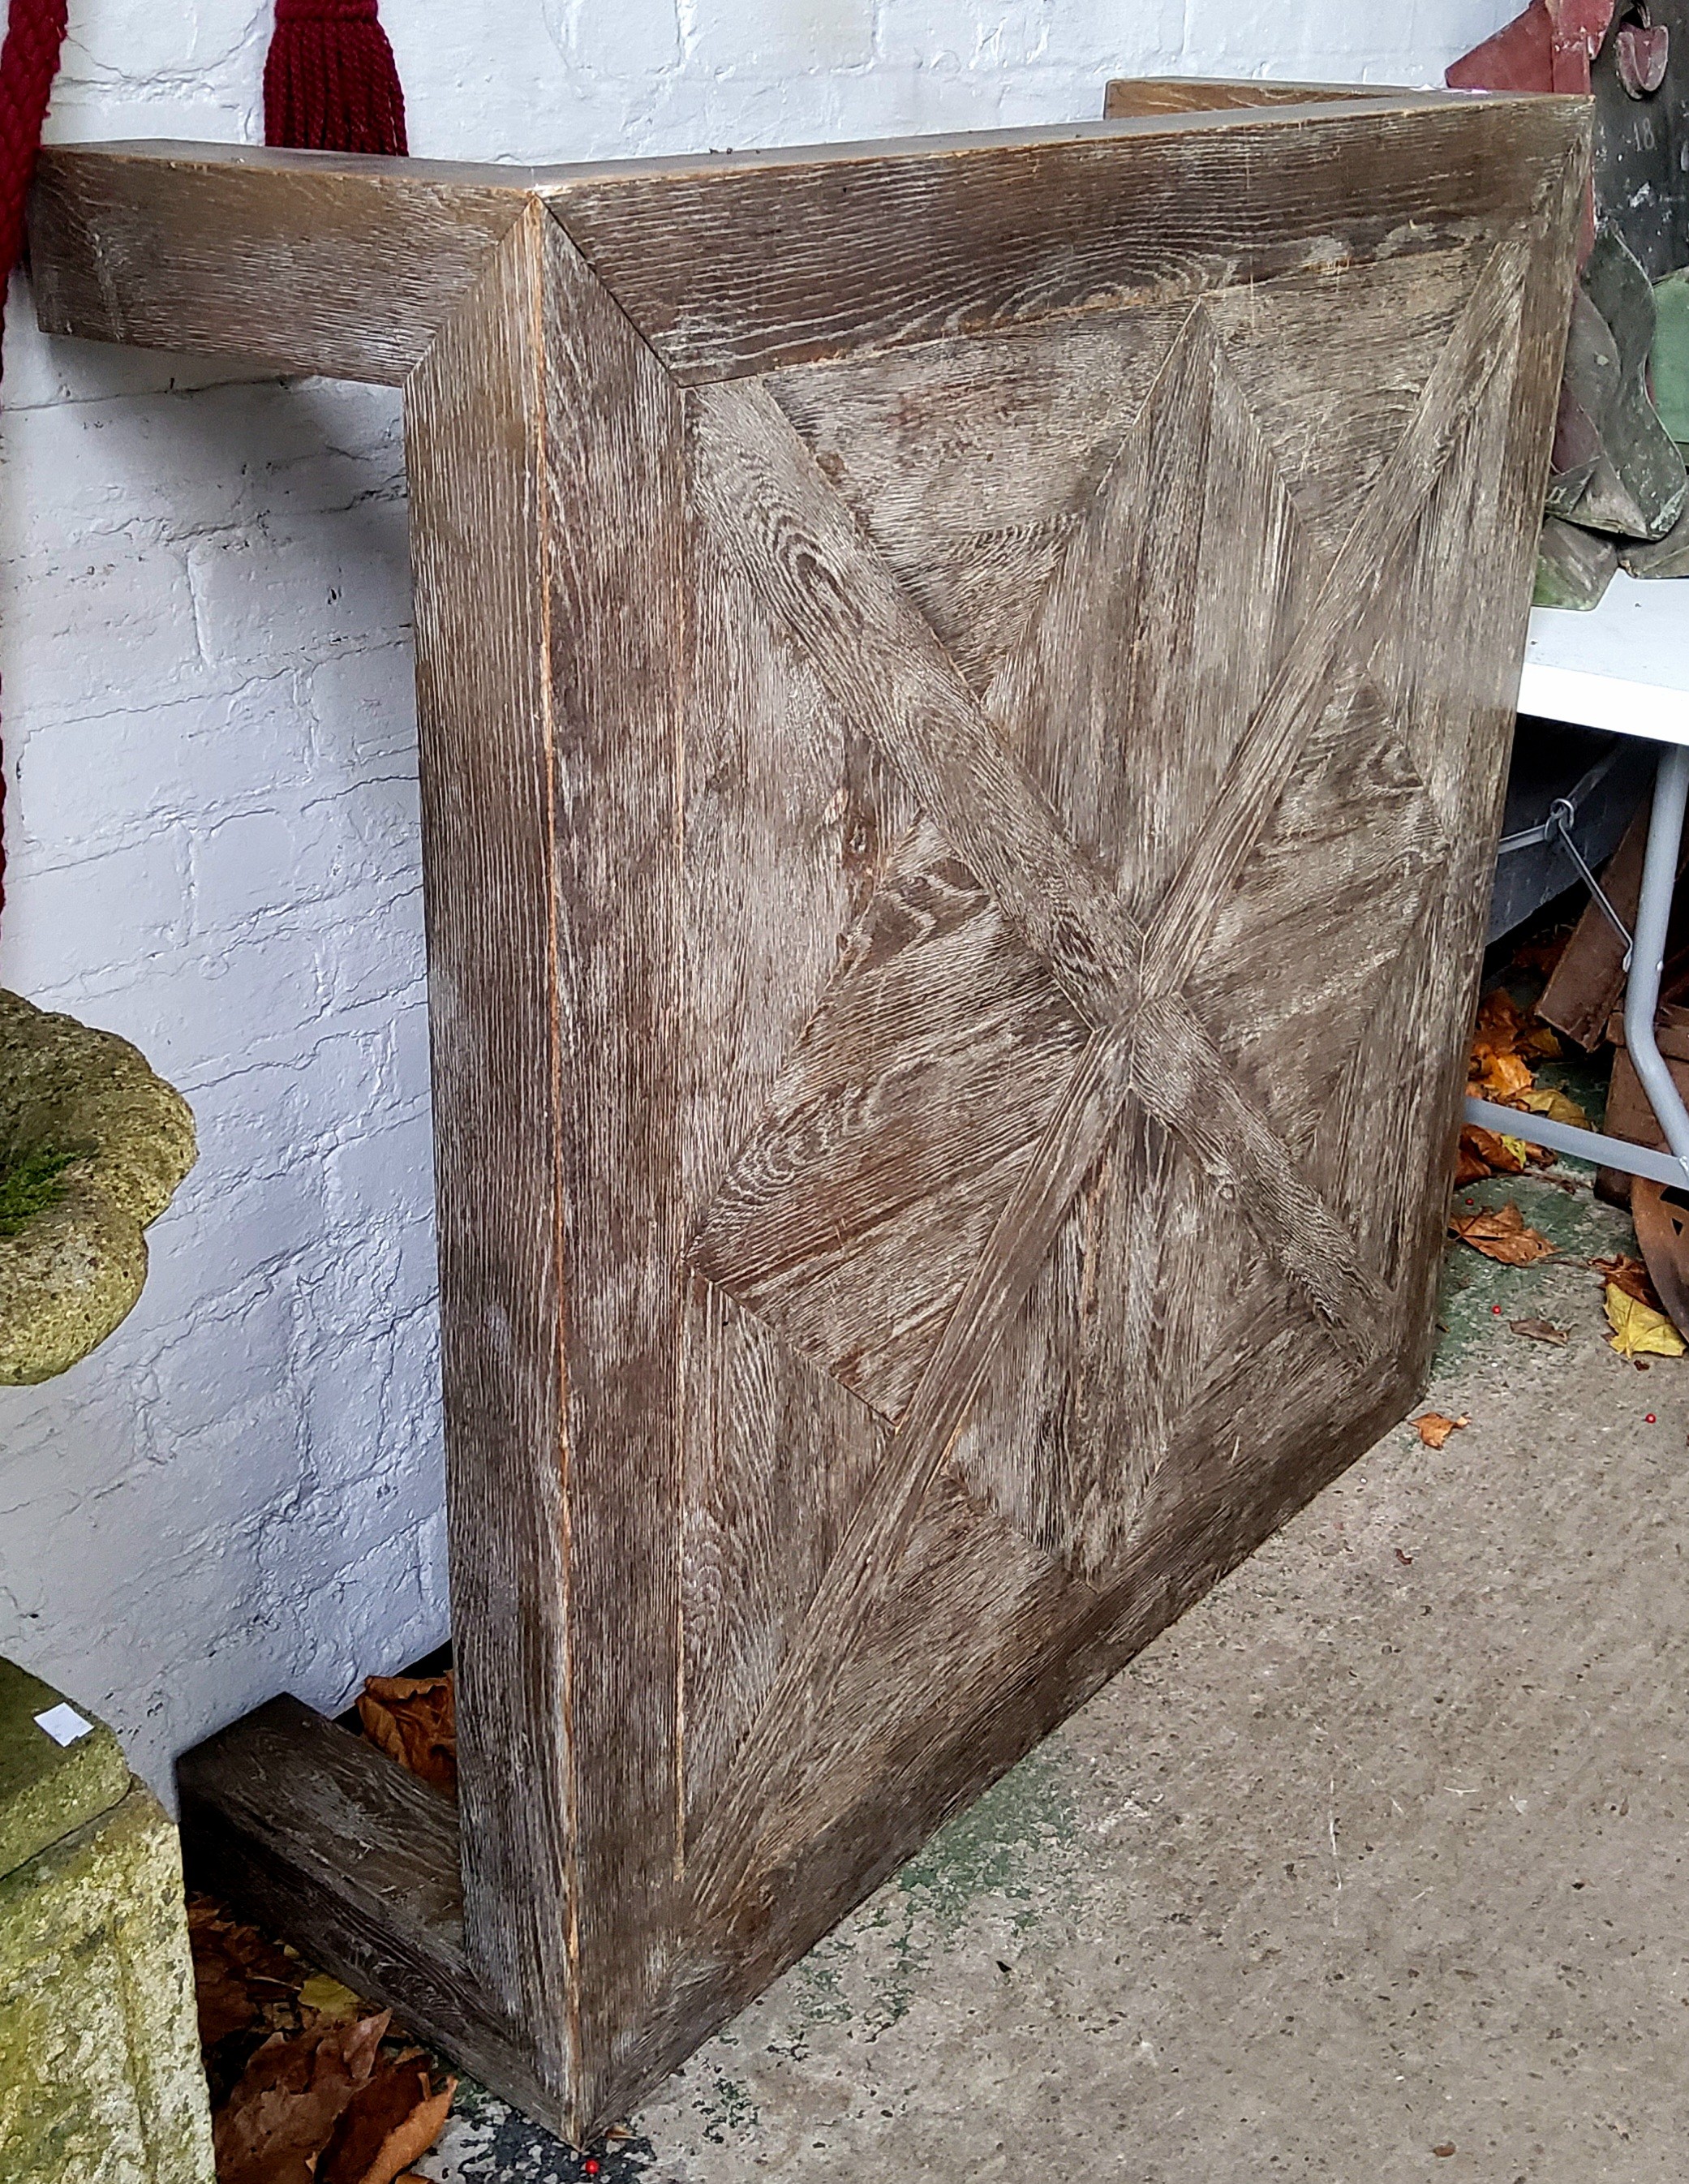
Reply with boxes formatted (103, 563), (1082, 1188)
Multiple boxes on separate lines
(264, 0), (409, 155)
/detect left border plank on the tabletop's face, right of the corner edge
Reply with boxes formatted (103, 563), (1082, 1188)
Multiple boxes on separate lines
(526, 209), (688, 2127)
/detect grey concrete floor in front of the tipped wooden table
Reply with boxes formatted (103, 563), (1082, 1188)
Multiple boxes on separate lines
(422, 1181), (1689, 2184)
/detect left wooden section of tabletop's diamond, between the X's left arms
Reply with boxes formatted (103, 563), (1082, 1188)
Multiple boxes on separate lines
(693, 826), (1088, 1420)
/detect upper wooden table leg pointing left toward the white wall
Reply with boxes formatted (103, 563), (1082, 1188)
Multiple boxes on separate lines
(31, 144), (539, 385)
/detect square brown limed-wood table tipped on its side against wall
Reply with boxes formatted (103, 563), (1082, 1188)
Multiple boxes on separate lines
(32, 88), (1586, 2134)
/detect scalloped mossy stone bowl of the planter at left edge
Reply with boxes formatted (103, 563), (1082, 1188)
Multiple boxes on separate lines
(0, 991), (196, 1386)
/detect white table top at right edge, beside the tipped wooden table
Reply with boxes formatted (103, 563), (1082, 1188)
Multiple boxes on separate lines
(1519, 572), (1689, 742)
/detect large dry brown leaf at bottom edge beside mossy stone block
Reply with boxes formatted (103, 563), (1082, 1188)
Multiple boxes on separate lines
(212, 2011), (387, 2184)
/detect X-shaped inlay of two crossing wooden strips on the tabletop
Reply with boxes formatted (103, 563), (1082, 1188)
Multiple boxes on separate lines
(677, 245), (1516, 1891)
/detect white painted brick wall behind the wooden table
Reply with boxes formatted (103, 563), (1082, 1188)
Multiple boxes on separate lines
(0, 0), (1515, 1786)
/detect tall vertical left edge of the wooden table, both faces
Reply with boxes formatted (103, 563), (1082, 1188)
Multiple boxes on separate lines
(409, 208), (686, 2123)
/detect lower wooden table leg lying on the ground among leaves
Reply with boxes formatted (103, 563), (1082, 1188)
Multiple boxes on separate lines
(177, 1699), (561, 2123)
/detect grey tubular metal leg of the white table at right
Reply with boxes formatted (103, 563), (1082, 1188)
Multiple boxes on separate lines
(1466, 742), (1689, 1190)
